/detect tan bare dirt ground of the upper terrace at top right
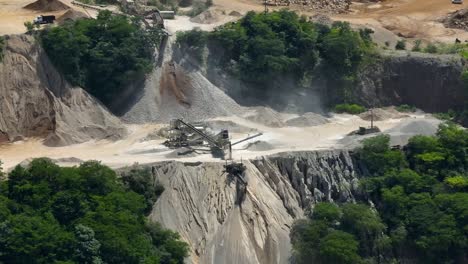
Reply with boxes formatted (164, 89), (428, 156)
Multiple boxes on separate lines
(214, 0), (468, 43)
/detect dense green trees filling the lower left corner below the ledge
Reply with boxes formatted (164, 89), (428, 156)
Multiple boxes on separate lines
(0, 159), (187, 264)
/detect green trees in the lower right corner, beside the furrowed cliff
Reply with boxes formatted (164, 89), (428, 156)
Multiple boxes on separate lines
(291, 125), (468, 263)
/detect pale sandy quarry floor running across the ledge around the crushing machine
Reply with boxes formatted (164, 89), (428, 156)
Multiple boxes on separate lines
(0, 115), (434, 170)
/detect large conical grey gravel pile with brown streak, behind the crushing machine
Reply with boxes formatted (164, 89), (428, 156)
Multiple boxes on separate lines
(122, 39), (243, 123)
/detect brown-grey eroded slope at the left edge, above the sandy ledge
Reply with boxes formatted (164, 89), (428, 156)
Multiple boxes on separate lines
(0, 35), (126, 146)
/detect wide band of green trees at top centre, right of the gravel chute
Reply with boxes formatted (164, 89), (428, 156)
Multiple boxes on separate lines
(177, 10), (373, 98)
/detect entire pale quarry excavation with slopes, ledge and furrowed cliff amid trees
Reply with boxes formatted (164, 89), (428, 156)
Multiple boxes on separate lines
(0, 0), (465, 264)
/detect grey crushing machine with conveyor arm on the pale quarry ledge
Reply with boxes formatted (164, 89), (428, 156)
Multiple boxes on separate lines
(163, 119), (263, 159)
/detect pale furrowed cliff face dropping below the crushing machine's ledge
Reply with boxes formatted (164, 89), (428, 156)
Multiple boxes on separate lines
(150, 150), (359, 264)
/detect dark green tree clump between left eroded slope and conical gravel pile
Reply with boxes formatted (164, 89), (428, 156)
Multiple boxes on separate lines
(40, 11), (160, 105)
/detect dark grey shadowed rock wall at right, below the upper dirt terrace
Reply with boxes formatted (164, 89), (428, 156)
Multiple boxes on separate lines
(352, 52), (466, 112)
